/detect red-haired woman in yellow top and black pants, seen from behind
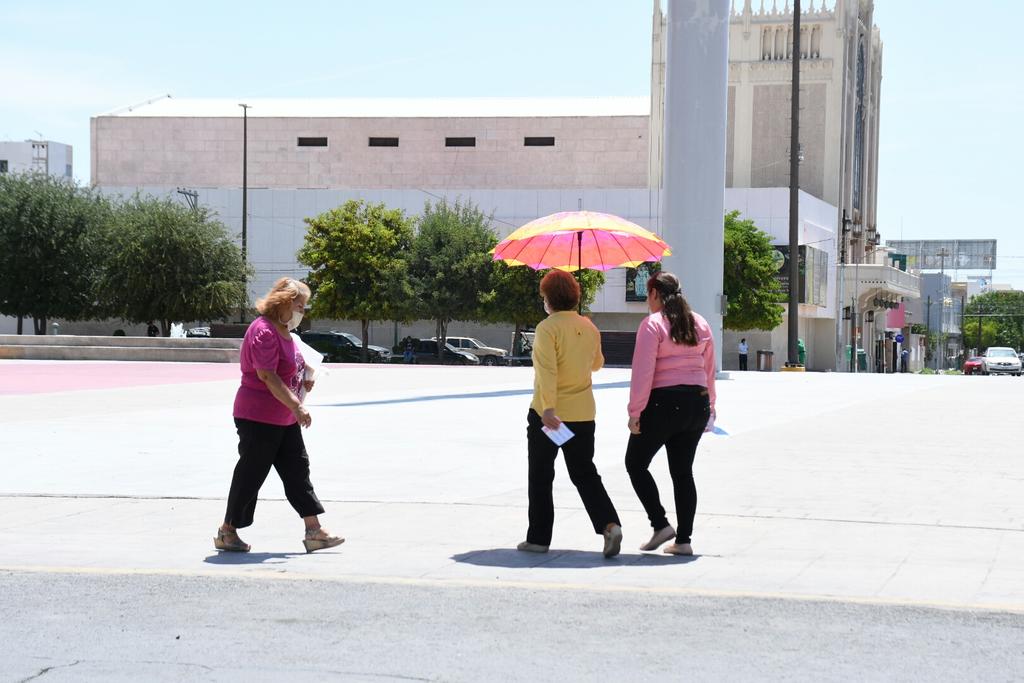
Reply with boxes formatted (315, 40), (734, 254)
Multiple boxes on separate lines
(517, 270), (623, 557)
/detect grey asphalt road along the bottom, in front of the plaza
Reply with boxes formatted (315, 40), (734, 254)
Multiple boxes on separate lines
(0, 572), (1024, 681)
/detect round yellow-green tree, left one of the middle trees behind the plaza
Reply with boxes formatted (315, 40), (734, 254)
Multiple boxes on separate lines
(298, 200), (413, 362)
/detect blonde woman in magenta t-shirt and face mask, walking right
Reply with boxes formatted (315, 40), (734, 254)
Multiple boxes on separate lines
(213, 278), (345, 553)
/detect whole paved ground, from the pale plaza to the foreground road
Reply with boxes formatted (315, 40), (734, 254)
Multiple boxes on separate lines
(0, 362), (1024, 681)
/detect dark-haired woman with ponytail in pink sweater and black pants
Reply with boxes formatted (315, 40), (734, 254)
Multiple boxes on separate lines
(626, 272), (715, 555)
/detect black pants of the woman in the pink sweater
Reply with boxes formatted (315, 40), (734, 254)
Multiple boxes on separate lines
(626, 387), (708, 543)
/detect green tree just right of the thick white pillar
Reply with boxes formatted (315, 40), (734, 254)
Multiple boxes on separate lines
(723, 211), (784, 330)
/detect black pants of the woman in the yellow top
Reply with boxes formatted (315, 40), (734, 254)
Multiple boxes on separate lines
(526, 410), (620, 546)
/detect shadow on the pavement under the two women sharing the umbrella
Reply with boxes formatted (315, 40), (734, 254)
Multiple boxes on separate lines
(452, 548), (700, 569)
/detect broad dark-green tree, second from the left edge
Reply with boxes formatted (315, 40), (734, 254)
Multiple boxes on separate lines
(100, 195), (249, 337)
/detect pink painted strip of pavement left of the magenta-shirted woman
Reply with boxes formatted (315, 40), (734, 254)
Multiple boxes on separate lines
(0, 360), (239, 394)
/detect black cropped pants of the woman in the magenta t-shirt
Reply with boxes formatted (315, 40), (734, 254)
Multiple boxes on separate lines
(224, 418), (324, 528)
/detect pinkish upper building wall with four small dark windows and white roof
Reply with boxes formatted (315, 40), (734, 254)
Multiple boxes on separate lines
(91, 97), (648, 189)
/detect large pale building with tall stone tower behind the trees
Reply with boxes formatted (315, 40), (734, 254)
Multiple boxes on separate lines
(91, 0), (897, 369)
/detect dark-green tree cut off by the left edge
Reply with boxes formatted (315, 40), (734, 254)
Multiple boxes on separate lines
(0, 173), (111, 335)
